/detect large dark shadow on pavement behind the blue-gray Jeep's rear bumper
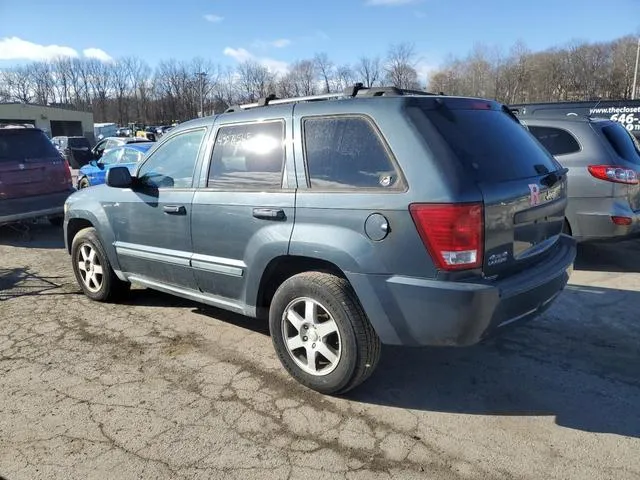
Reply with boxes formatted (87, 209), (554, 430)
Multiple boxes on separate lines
(347, 287), (640, 438)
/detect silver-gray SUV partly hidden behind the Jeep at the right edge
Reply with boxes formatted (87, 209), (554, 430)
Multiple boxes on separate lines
(521, 116), (640, 241)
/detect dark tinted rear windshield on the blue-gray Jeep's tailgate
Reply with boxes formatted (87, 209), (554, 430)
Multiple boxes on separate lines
(408, 104), (561, 182)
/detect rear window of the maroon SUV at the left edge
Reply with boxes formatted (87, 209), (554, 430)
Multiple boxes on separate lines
(0, 128), (60, 162)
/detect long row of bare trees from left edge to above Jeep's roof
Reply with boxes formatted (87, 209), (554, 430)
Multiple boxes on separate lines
(0, 43), (421, 125)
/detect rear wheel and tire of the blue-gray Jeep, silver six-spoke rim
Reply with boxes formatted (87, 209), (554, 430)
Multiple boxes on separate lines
(269, 272), (381, 394)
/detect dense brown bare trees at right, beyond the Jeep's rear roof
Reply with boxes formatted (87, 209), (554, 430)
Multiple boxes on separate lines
(429, 36), (638, 104)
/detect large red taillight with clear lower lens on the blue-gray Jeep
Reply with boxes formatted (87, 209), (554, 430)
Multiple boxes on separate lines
(409, 203), (484, 270)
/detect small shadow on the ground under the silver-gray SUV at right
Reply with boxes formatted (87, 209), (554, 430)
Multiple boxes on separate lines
(574, 242), (640, 273)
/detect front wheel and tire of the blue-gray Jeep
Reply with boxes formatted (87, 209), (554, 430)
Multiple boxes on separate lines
(71, 227), (131, 302)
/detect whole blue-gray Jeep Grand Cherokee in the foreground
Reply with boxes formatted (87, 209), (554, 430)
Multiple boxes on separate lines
(65, 85), (576, 393)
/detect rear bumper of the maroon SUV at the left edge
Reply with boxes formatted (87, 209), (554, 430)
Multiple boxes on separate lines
(0, 190), (75, 225)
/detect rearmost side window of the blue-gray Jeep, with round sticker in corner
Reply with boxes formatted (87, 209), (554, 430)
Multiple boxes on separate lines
(303, 117), (400, 189)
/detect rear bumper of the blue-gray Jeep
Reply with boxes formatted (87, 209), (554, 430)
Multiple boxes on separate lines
(347, 235), (576, 346)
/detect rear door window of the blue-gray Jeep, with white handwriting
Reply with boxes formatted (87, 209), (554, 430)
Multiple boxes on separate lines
(207, 121), (284, 189)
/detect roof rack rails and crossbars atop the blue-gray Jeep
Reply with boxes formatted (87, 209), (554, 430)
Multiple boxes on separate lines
(224, 82), (437, 113)
